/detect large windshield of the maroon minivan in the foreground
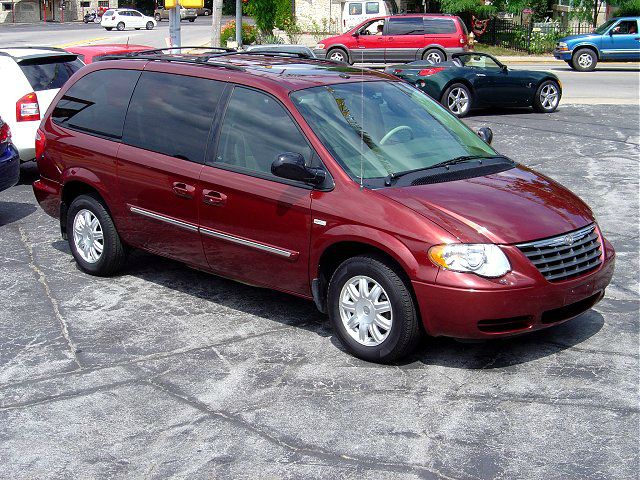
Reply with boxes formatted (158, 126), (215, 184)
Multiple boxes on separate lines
(291, 81), (497, 180)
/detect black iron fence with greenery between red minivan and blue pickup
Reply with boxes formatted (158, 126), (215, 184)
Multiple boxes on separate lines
(476, 18), (593, 54)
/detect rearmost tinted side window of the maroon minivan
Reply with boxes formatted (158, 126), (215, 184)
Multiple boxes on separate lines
(51, 69), (140, 139)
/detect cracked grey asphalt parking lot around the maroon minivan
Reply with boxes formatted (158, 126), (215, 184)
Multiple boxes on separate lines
(0, 104), (640, 480)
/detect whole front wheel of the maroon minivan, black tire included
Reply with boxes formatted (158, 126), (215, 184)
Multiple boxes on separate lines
(327, 256), (422, 363)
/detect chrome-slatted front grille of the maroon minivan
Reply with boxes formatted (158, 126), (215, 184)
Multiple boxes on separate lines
(516, 224), (602, 282)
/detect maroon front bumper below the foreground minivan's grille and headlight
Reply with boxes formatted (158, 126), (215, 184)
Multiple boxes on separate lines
(412, 241), (615, 339)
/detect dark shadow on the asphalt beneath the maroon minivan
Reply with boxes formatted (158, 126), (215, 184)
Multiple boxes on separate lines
(52, 244), (604, 370)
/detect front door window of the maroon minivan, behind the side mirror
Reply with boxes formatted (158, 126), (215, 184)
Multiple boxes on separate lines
(215, 87), (311, 175)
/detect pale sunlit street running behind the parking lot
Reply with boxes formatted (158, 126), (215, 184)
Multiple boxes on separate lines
(0, 22), (640, 105)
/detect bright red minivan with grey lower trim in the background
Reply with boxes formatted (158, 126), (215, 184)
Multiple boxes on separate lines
(316, 14), (469, 63)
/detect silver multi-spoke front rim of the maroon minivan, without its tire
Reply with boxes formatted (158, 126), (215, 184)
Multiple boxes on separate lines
(340, 275), (393, 347)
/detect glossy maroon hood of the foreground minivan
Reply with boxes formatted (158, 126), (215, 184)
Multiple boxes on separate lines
(377, 165), (594, 244)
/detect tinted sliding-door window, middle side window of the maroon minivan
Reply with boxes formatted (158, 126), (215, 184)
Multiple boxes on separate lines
(122, 72), (225, 163)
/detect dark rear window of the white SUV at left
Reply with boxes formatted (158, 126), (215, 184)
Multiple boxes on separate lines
(18, 55), (83, 92)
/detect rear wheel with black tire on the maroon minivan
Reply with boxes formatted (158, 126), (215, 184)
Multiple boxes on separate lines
(67, 195), (126, 276)
